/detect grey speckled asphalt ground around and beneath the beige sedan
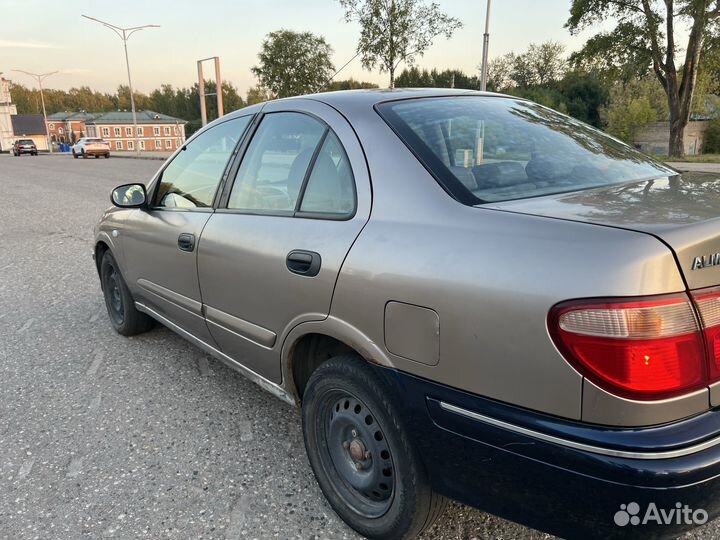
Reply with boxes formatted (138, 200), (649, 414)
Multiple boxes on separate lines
(0, 155), (720, 540)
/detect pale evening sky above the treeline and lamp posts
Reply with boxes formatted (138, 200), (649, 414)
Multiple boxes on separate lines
(0, 0), (608, 95)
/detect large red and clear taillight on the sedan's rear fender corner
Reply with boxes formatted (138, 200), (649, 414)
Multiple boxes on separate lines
(549, 294), (707, 400)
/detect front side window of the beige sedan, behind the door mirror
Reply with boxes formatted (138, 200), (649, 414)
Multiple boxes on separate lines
(155, 116), (252, 208)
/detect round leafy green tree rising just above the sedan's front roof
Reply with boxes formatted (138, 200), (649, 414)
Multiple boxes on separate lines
(252, 30), (334, 98)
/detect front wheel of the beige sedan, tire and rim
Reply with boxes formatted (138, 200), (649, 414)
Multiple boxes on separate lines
(100, 251), (154, 336)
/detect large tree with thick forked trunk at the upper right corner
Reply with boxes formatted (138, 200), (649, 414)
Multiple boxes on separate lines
(566, 0), (720, 157)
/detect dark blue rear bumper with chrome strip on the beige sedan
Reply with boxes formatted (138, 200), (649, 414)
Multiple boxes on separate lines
(378, 368), (720, 538)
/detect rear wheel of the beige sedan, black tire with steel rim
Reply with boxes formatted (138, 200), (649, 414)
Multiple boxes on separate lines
(302, 355), (447, 540)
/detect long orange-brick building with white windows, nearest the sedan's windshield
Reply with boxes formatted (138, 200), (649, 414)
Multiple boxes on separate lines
(85, 111), (187, 151)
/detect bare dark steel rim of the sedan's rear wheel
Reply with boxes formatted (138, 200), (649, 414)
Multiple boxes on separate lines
(320, 390), (396, 519)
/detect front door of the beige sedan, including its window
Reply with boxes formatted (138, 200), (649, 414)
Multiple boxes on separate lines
(121, 115), (252, 344)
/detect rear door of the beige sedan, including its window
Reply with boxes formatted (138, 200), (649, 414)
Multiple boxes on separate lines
(198, 100), (371, 382)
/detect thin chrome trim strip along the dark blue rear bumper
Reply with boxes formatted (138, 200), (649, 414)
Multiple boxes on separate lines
(440, 401), (720, 459)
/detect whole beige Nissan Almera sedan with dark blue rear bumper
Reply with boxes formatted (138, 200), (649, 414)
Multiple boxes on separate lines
(94, 90), (720, 539)
